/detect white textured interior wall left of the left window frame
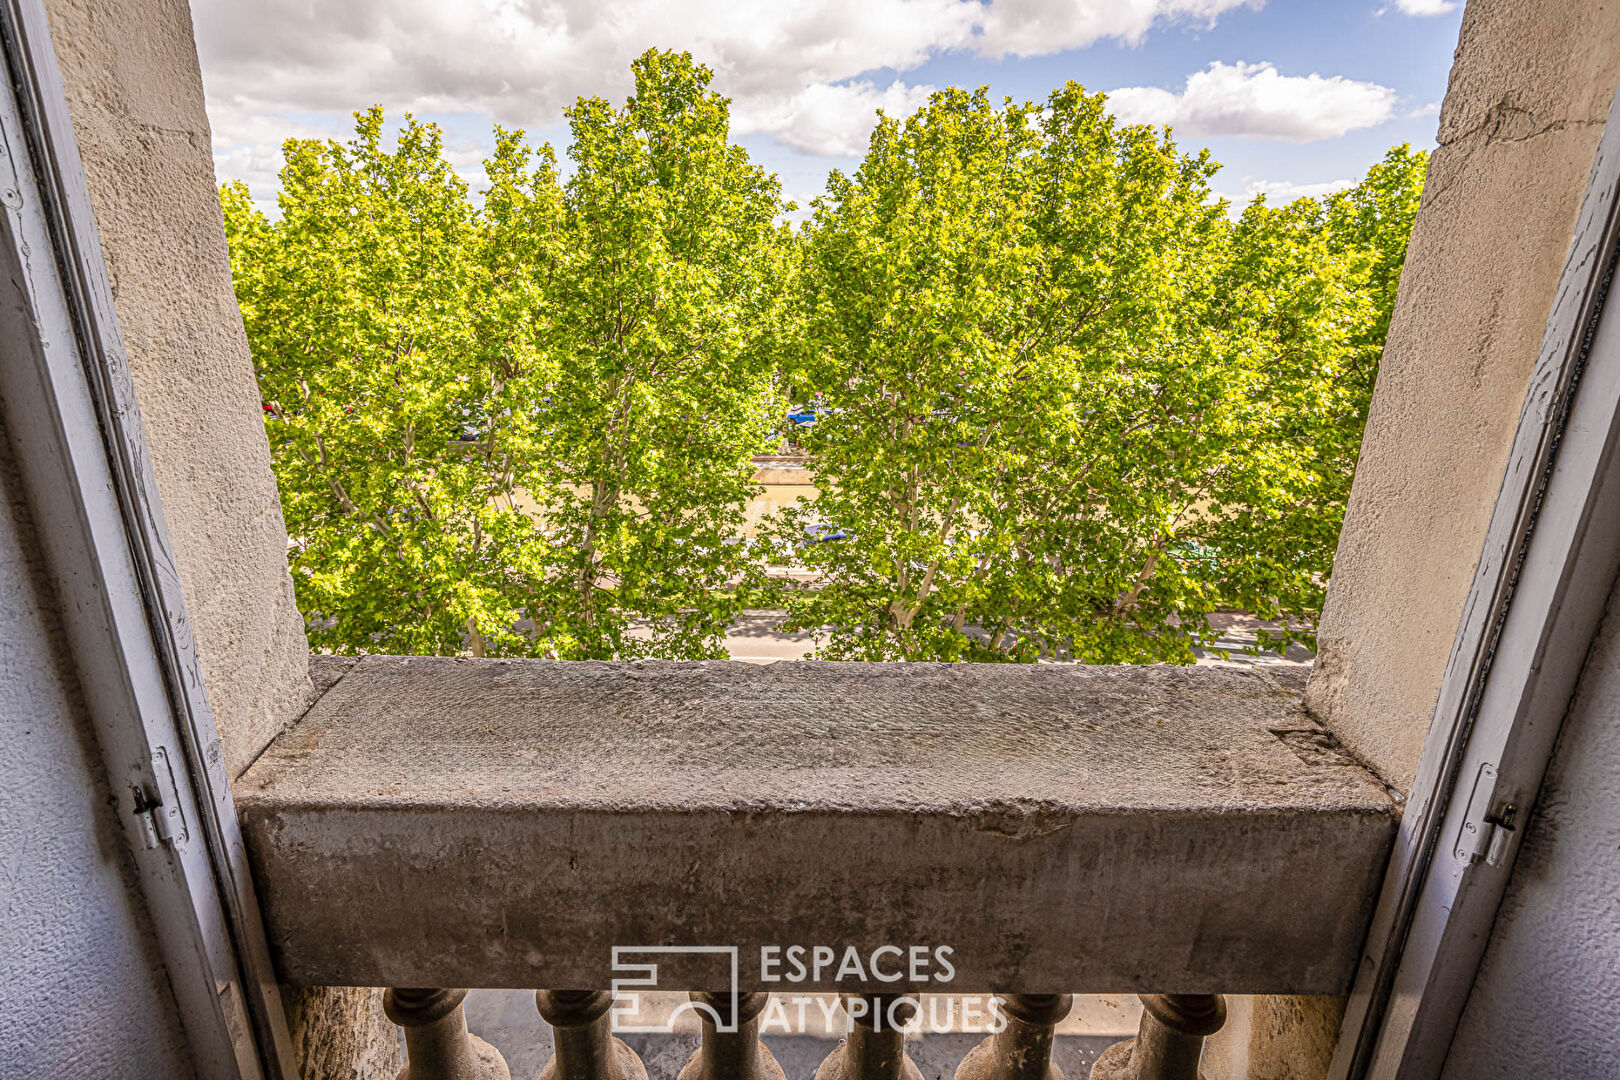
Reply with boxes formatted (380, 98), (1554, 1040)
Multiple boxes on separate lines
(0, 417), (193, 1080)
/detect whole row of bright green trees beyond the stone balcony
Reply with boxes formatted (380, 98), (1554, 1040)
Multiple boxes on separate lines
(222, 52), (1426, 662)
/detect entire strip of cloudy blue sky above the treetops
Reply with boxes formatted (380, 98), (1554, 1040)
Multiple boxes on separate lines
(191, 0), (1463, 220)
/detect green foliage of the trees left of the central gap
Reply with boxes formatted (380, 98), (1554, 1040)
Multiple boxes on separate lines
(222, 52), (787, 659)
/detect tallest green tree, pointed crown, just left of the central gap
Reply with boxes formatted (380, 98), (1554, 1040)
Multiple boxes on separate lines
(486, 50), (791, 657)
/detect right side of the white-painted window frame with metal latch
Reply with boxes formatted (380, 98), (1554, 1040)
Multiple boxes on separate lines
(1328, 76), (1620, 1080)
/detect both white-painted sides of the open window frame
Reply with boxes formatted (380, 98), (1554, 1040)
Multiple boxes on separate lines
(0, 0), (1620, 1080)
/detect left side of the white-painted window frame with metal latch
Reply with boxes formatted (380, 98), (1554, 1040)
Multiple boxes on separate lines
(0, 0), (298, 1080)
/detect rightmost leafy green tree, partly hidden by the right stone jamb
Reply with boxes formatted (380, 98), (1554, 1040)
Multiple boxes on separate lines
(1197, 144), (1429, 660)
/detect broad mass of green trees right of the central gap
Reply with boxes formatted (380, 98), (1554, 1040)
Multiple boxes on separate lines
(782, 84), (1421, 662)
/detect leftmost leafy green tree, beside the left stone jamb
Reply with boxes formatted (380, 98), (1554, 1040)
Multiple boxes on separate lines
(222, 108), (549, 656)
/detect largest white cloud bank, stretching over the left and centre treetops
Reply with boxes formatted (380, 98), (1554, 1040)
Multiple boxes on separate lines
(191, 0), (1262, 191)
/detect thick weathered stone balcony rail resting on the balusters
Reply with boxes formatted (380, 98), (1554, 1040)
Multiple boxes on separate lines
(237, 656), (1395, 993)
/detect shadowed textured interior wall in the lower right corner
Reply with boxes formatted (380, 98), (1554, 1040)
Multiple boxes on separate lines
(1442, 569), (1620, 1080)
